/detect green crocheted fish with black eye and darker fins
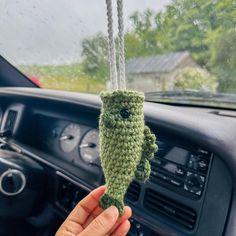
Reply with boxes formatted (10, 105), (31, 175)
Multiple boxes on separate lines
(99, 90), (157, 215)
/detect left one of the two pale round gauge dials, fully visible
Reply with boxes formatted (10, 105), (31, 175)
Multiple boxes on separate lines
(60, 124), (80, 152)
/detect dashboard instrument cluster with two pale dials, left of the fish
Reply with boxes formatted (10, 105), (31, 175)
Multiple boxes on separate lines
(36, 115), (100, 166)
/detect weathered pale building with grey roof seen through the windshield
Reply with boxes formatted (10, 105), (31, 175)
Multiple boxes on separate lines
(126, 51), (199, 92)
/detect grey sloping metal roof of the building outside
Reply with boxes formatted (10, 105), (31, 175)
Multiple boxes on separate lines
(126, 51), (190, 74)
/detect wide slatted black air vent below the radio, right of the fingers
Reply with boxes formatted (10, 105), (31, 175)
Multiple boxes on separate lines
(144, 189), (197, 230)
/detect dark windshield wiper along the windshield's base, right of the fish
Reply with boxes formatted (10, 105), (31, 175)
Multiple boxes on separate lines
(145, 90), (236, 108)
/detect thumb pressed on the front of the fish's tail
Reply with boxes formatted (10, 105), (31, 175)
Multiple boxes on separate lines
(79, 206), (119, 236)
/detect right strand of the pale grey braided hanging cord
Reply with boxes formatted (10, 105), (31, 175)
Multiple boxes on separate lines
(117, 0), (126, 90)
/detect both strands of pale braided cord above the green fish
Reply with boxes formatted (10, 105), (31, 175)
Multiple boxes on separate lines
(106, 0), (126, 90)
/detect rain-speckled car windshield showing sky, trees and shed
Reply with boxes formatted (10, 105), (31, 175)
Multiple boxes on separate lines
(0, 0), (236, 105)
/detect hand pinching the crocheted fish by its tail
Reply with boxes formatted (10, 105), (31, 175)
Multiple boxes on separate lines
(56, 186), (132, 236)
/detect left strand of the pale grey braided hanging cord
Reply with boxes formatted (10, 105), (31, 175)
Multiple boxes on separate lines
(106, 0), (118, 89)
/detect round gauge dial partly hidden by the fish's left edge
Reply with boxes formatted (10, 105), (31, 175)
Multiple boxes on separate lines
(79, 129), (99, 163)
